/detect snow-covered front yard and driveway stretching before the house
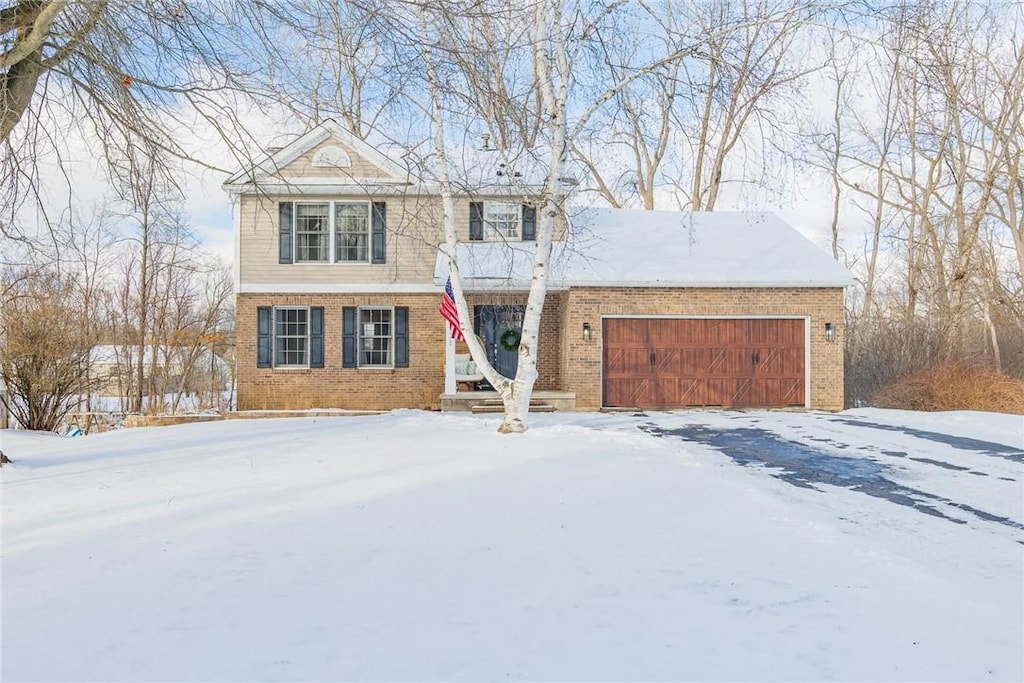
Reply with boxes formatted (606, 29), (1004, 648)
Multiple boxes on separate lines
(0, 410), (1024, 681)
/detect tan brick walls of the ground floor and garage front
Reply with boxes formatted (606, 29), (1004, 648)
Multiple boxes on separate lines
(238, 288), (843, 411)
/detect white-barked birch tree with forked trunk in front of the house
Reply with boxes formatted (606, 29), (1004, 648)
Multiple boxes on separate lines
(418, 0), (720, 433)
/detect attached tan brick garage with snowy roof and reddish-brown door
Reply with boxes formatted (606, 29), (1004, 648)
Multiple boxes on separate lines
(444, 208), (853, 411)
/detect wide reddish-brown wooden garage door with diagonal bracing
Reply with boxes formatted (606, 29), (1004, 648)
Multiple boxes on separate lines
(602, 317), (805, 408)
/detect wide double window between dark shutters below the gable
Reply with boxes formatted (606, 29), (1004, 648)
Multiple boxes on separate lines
(278, 202), (387, 263)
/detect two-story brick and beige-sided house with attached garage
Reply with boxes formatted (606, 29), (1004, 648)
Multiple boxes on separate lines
(224, 122), (851, 410)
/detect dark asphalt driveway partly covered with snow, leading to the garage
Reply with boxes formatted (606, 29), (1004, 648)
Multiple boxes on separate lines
(642, 413), (1024, 544)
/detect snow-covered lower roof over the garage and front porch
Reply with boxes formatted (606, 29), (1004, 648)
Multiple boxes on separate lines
(434, 208), (853, 291)
